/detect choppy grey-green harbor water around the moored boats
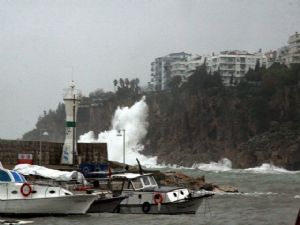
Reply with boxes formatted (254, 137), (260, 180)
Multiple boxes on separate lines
(1, 166), (300, 225)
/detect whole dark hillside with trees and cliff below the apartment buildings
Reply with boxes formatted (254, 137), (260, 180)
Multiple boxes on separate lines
(23, 64), (300, 170)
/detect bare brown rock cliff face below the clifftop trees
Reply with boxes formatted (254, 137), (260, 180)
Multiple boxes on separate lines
(24, 85), (300, 170)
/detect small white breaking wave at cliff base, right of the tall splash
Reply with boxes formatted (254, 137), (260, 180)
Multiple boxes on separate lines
(192, 158), (232, 172)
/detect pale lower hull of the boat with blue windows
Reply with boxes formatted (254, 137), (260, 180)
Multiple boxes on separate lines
(0, 195), (96, 215)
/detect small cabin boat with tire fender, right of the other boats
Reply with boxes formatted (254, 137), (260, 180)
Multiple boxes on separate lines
(111, 173), (213, 214)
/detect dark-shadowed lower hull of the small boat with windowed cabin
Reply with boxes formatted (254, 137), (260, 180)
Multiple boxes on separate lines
(119, 197), (204, 214)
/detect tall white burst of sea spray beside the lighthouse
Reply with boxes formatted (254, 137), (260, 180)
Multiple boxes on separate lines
(78, 97), (157, 167)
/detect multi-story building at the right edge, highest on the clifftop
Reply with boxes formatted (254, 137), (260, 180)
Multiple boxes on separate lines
(278, 32), (300, 66)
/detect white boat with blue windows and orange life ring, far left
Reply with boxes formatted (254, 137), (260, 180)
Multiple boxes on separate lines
(0, 169), (96, 215)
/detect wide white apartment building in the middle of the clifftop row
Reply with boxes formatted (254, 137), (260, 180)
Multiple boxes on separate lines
(207, 50), (270, 86)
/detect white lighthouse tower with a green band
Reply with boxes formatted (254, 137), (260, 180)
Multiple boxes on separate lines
(61, 81), (81, 165)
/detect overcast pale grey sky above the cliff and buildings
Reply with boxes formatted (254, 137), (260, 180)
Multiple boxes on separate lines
(0, 0), (300, 139)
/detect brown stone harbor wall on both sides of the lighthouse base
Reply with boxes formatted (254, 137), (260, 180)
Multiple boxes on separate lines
(0, 140), (107, 168)
